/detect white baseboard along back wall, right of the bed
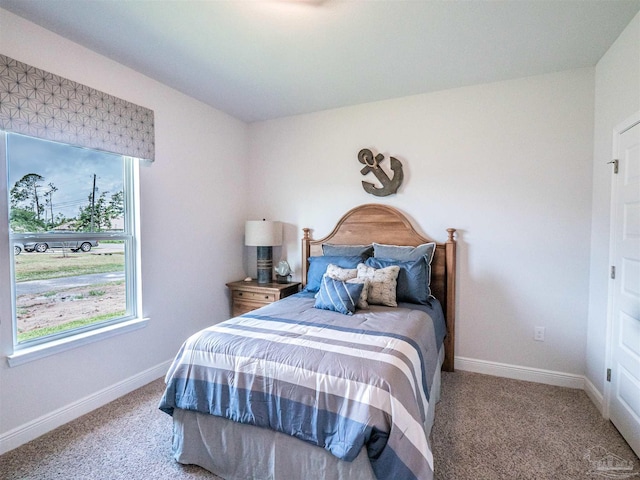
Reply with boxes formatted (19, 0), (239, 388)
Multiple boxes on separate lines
(455, 357), (585, 390)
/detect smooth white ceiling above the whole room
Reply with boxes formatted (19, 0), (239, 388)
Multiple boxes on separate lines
(0, 0), (640, 122)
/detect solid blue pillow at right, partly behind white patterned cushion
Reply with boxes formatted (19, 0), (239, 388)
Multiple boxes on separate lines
(365, 256), (431, 305)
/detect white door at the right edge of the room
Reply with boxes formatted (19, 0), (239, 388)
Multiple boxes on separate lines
(609, 114), (640, 456)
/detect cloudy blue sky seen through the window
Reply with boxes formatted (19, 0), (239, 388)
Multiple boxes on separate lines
(7, 134), (124, 218)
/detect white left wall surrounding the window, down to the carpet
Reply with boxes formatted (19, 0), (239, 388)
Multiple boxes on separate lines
(0, 10), (248, 452)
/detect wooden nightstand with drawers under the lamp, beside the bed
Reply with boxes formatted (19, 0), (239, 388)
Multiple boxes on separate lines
(227, 280), (300, 317)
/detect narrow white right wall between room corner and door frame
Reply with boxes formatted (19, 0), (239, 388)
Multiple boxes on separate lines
(585, 14), (640, 394)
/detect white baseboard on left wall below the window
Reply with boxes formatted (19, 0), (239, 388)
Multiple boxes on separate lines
(0, 361), (171, 455)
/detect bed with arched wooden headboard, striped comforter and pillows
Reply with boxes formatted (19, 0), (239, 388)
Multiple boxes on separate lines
(160, 204), (456, 480)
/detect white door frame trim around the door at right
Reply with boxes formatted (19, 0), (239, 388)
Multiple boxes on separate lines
(602, 111), (640, 420)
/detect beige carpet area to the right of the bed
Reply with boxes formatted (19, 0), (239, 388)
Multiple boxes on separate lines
(432, 372), (640, 480)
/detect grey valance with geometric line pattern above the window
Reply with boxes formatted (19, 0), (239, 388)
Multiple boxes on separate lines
(0, 55), (155, 161)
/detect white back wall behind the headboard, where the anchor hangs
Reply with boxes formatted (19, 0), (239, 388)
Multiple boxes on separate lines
(249, 69), (594, 380)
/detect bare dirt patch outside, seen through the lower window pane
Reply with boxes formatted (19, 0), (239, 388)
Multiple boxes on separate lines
(16, 283), (126, 333)
